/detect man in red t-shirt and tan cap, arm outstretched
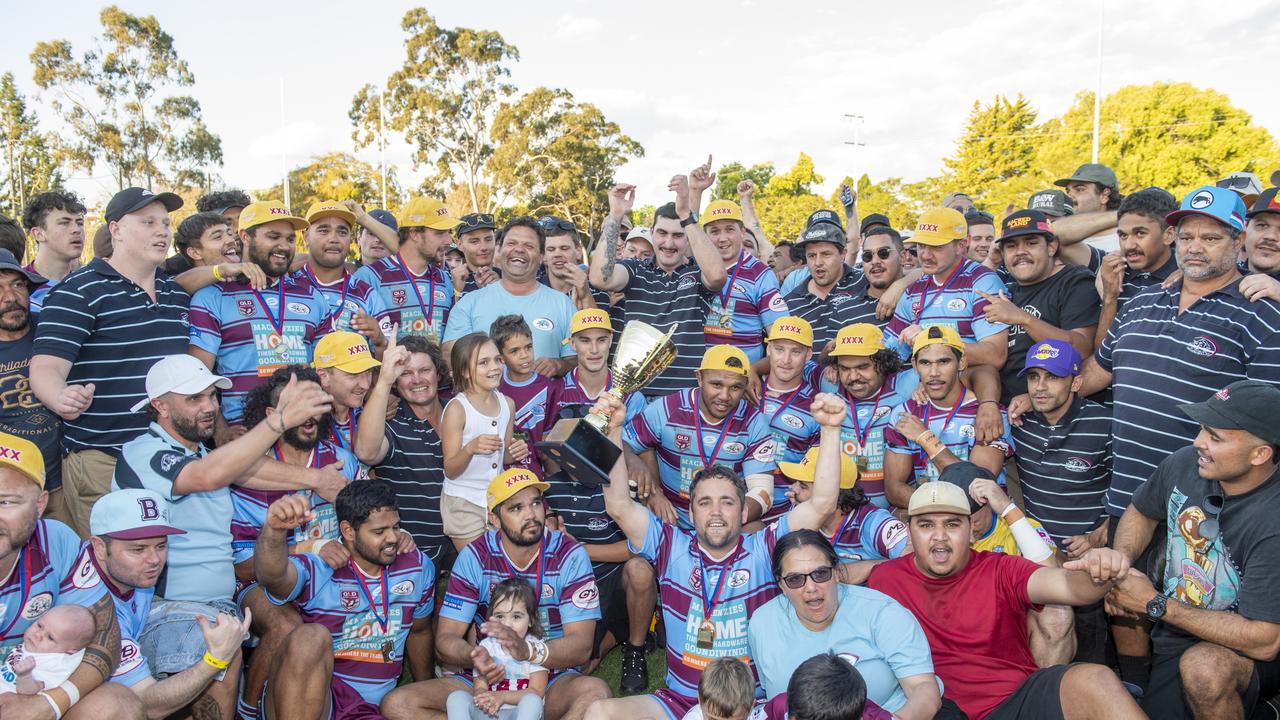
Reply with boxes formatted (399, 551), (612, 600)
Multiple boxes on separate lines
(867, 482), (1146, 720)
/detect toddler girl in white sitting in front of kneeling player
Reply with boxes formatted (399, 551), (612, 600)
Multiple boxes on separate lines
(445, 578), (550, 720)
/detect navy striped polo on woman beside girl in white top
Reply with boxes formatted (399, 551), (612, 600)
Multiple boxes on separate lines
(374, 402), (454, 570)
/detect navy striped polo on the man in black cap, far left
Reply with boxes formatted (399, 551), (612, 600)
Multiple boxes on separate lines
(32, 258), (191, 455)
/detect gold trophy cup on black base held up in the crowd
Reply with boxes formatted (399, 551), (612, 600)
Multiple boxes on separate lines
(536, 320), (676, 486)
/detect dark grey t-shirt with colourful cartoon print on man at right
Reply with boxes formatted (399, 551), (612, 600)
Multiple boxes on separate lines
(1133, 447), (1280, 655)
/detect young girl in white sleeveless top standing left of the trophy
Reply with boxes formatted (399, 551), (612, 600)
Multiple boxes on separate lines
(440, 333), (529, 550)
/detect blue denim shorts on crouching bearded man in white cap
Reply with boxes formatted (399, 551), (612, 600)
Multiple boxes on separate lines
(138, 597), (243, 680)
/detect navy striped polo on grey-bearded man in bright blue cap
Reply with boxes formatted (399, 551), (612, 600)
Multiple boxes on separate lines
(1094, 275), (1280, 516)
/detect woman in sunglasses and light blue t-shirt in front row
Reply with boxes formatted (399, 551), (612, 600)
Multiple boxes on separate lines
(748, 530), (964, 720)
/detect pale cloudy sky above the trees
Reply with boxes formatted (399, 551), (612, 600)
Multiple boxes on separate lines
(0, 0), (1280, 204)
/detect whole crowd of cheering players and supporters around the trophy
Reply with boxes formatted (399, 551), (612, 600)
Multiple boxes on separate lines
(0, 152), (1280, 720)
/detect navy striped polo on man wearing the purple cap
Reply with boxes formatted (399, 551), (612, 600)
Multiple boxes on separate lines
(1012, 397), (1111, 551)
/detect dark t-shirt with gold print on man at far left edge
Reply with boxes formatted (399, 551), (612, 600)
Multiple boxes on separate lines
(0, 327), (63, 491)
